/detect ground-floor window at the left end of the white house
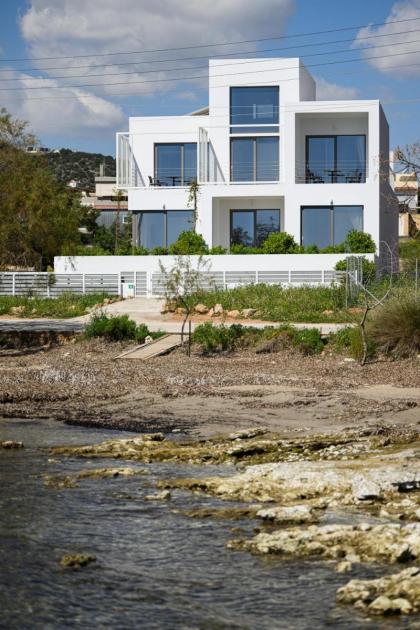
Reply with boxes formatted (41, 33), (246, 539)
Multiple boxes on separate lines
(137, 210), (194, 249)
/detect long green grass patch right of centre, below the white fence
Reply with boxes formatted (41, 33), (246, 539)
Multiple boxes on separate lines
(186, 284), (351, 323)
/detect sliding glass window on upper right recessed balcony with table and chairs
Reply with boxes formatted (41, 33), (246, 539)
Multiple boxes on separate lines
(306, 135), (366, 184)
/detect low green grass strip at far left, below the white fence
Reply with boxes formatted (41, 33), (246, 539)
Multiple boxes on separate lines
(0, 293), (112, 319)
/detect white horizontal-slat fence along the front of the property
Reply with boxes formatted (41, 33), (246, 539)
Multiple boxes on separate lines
(0, 269), (345, 298)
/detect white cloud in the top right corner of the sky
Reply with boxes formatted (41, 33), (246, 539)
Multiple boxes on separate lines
(353, 0), (420, 77)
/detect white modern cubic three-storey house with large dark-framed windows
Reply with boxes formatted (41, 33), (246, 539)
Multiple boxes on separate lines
(117, 58), (398, 268)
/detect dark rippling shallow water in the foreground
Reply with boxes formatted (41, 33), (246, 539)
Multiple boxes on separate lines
(0, 420), (411, 630)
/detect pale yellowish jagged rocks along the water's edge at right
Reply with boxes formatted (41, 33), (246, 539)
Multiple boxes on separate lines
(45, 426), (420, 616)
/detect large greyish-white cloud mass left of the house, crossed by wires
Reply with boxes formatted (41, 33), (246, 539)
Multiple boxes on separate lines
(13, 0), (295, 143)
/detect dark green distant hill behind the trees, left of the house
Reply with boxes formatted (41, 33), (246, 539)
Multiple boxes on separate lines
(44, 149), (115, 191)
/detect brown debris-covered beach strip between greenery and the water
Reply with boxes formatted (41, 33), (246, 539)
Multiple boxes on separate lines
(0, 340), (420, 435)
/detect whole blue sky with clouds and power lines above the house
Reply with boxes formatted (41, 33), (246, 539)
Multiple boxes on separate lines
(0, 0), (420, 154)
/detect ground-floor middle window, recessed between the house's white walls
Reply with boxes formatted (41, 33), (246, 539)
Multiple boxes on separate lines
(230, 209), (280, 247)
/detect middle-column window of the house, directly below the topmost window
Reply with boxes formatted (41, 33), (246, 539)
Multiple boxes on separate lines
(230, 136), (279, 182)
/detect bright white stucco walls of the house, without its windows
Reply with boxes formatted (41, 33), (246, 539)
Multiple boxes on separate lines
(118, 58), (398, 260)
